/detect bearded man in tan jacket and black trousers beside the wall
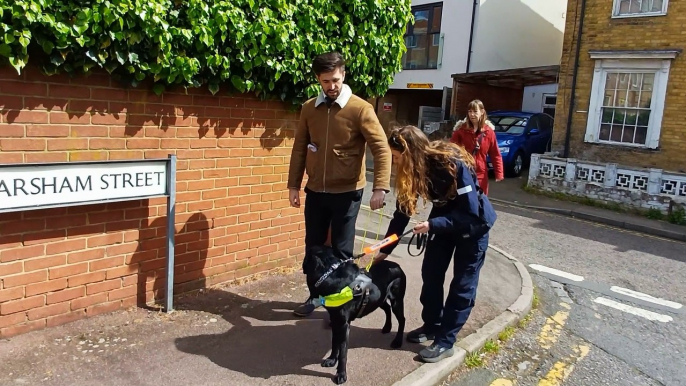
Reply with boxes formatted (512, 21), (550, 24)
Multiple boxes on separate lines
(288, 52), (391, 316)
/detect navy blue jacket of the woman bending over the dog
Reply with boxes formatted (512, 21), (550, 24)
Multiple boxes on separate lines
(380, 155), (497, 253)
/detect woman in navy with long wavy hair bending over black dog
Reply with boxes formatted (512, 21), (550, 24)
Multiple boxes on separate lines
(376, 126), (496, 362)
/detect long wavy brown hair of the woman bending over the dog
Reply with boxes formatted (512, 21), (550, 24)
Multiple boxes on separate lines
(388, 126), (475, 216)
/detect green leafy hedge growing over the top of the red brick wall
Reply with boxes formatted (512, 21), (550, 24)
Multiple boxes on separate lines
(0, 0), (411, 103)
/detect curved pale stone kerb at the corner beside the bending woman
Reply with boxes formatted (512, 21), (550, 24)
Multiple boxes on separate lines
(393, 245), (534, 386)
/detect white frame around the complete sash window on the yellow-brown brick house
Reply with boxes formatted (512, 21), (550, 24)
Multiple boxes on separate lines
(584, 52), (676, 150)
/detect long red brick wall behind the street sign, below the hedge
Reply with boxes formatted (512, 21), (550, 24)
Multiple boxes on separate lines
(0, 68), (304, 337)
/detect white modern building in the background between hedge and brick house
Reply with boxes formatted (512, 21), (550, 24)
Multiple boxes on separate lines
(378, 0), (567, 131)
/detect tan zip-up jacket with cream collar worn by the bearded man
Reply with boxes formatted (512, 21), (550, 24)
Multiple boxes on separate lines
(288, 84), (391, 193)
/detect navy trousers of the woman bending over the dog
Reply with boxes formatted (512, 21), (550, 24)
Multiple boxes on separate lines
(419, 233), (489, 348)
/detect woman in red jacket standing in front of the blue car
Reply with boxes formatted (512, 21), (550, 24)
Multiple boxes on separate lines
(450, 99), (504, 195)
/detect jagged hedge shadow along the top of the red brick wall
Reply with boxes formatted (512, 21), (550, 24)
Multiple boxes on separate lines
(0, 66), (298, 139)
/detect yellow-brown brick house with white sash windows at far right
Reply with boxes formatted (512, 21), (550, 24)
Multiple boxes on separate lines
(553, 0), (686, 171)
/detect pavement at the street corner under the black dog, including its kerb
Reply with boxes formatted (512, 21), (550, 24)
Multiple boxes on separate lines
(0, 191), (533, 386)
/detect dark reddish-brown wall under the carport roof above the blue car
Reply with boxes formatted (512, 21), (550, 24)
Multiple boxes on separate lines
(451, 82), (524, 119)
